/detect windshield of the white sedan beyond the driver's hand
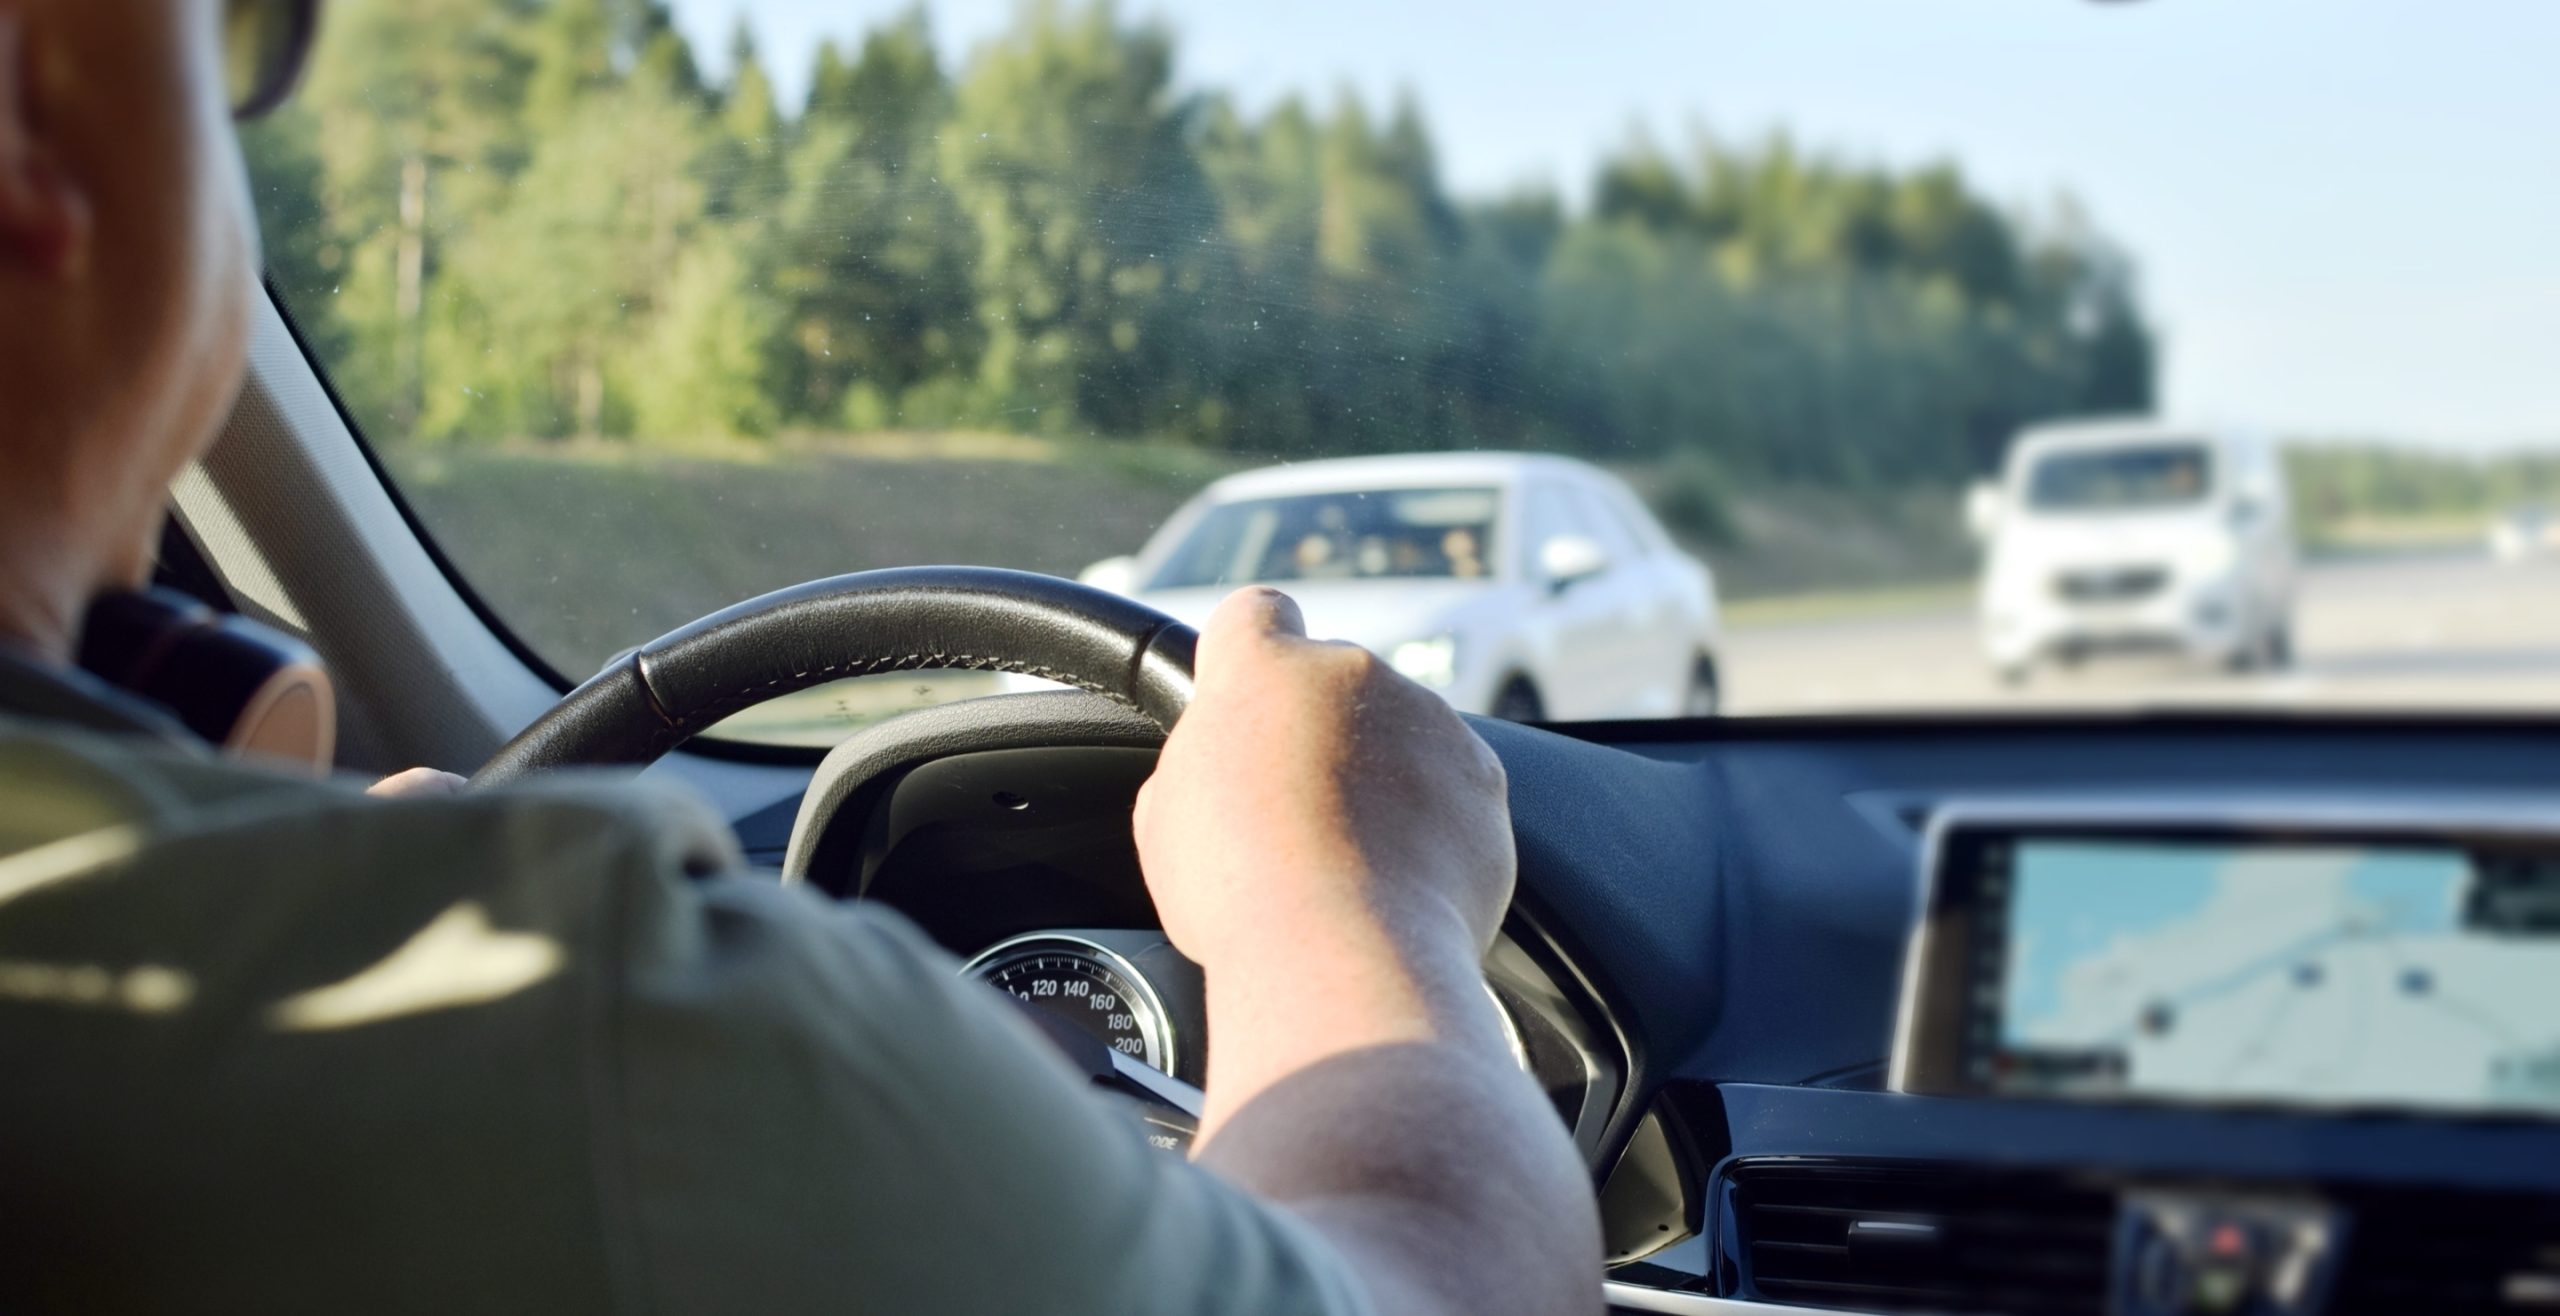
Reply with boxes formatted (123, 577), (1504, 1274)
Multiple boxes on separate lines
(1147, 489), (1503, 589)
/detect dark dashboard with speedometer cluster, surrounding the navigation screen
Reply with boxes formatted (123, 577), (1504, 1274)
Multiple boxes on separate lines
(706, 696), (2560, 1316)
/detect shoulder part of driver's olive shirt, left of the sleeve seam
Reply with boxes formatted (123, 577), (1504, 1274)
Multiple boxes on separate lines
(0, 722), (730, 1311)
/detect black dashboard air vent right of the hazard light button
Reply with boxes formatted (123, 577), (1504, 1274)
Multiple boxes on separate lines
(2330, 1193), (2560, 1316)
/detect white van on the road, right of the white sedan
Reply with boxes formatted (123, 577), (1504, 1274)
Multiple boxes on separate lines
(1966, 420), (2294, 684)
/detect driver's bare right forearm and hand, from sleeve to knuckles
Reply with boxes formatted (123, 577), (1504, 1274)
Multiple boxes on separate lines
(1137, 589), (1600, 1316)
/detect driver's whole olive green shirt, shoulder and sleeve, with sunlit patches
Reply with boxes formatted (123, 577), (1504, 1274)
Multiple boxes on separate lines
(0, 719), (1367, 1316)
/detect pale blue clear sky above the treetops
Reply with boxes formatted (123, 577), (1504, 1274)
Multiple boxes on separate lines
(673, 0), (2560, 448)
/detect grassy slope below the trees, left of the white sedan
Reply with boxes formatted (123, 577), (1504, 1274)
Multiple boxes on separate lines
(389, 435), (1228, 673)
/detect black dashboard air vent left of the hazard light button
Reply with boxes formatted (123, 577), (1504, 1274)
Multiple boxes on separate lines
(1720, 1160), (2117, 1316)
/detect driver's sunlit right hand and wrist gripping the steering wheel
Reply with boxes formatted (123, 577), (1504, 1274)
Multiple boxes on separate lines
(1137, 586), (1513, 1134)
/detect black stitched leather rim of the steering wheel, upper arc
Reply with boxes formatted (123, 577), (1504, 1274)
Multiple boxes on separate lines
(471, 566), (1198, 786)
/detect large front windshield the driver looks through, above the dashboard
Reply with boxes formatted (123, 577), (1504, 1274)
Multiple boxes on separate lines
(243, 0), (2560, 745)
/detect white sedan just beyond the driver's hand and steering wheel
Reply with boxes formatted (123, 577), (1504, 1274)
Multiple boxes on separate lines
(1083, 453), (1718, 722)
